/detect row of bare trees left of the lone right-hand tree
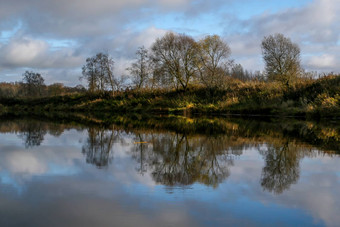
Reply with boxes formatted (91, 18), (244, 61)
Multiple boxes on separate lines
(81, 32), (264, 93)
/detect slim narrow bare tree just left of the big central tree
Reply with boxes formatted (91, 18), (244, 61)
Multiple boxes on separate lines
(127, 46), (151, 89)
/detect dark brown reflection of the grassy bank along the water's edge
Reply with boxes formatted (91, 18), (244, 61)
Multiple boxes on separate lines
(107, 115), (340, 153)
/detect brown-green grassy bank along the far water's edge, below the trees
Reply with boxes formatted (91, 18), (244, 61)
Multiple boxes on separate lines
(0, 76), (340, 118)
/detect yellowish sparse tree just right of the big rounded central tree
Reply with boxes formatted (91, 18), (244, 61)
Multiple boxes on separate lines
(198, 35), (231, 88)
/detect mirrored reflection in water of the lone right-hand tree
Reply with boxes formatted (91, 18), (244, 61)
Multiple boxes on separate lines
(261, 142), (301, 194)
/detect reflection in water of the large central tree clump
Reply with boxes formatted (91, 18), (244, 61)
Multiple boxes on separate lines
(132, 133), (239, 187)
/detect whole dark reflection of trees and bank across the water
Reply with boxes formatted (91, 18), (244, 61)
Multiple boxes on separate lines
(0, 117), (340, 194)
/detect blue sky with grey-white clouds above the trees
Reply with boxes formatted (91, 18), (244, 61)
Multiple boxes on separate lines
(0, 0), (340, 86)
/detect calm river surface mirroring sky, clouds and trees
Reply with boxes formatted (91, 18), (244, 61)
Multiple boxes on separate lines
(0, 118), (340, 226)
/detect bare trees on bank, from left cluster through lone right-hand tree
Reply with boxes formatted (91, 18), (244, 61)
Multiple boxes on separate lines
(82, 32), (330, 93)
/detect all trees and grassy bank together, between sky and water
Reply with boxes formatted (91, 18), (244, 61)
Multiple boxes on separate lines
(0, 32), (340, 118)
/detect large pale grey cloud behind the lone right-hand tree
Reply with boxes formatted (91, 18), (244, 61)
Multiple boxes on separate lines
(225, 0), (340, 72)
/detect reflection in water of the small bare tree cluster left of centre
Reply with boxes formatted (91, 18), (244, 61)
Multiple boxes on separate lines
(82, 128), (118, 168)
